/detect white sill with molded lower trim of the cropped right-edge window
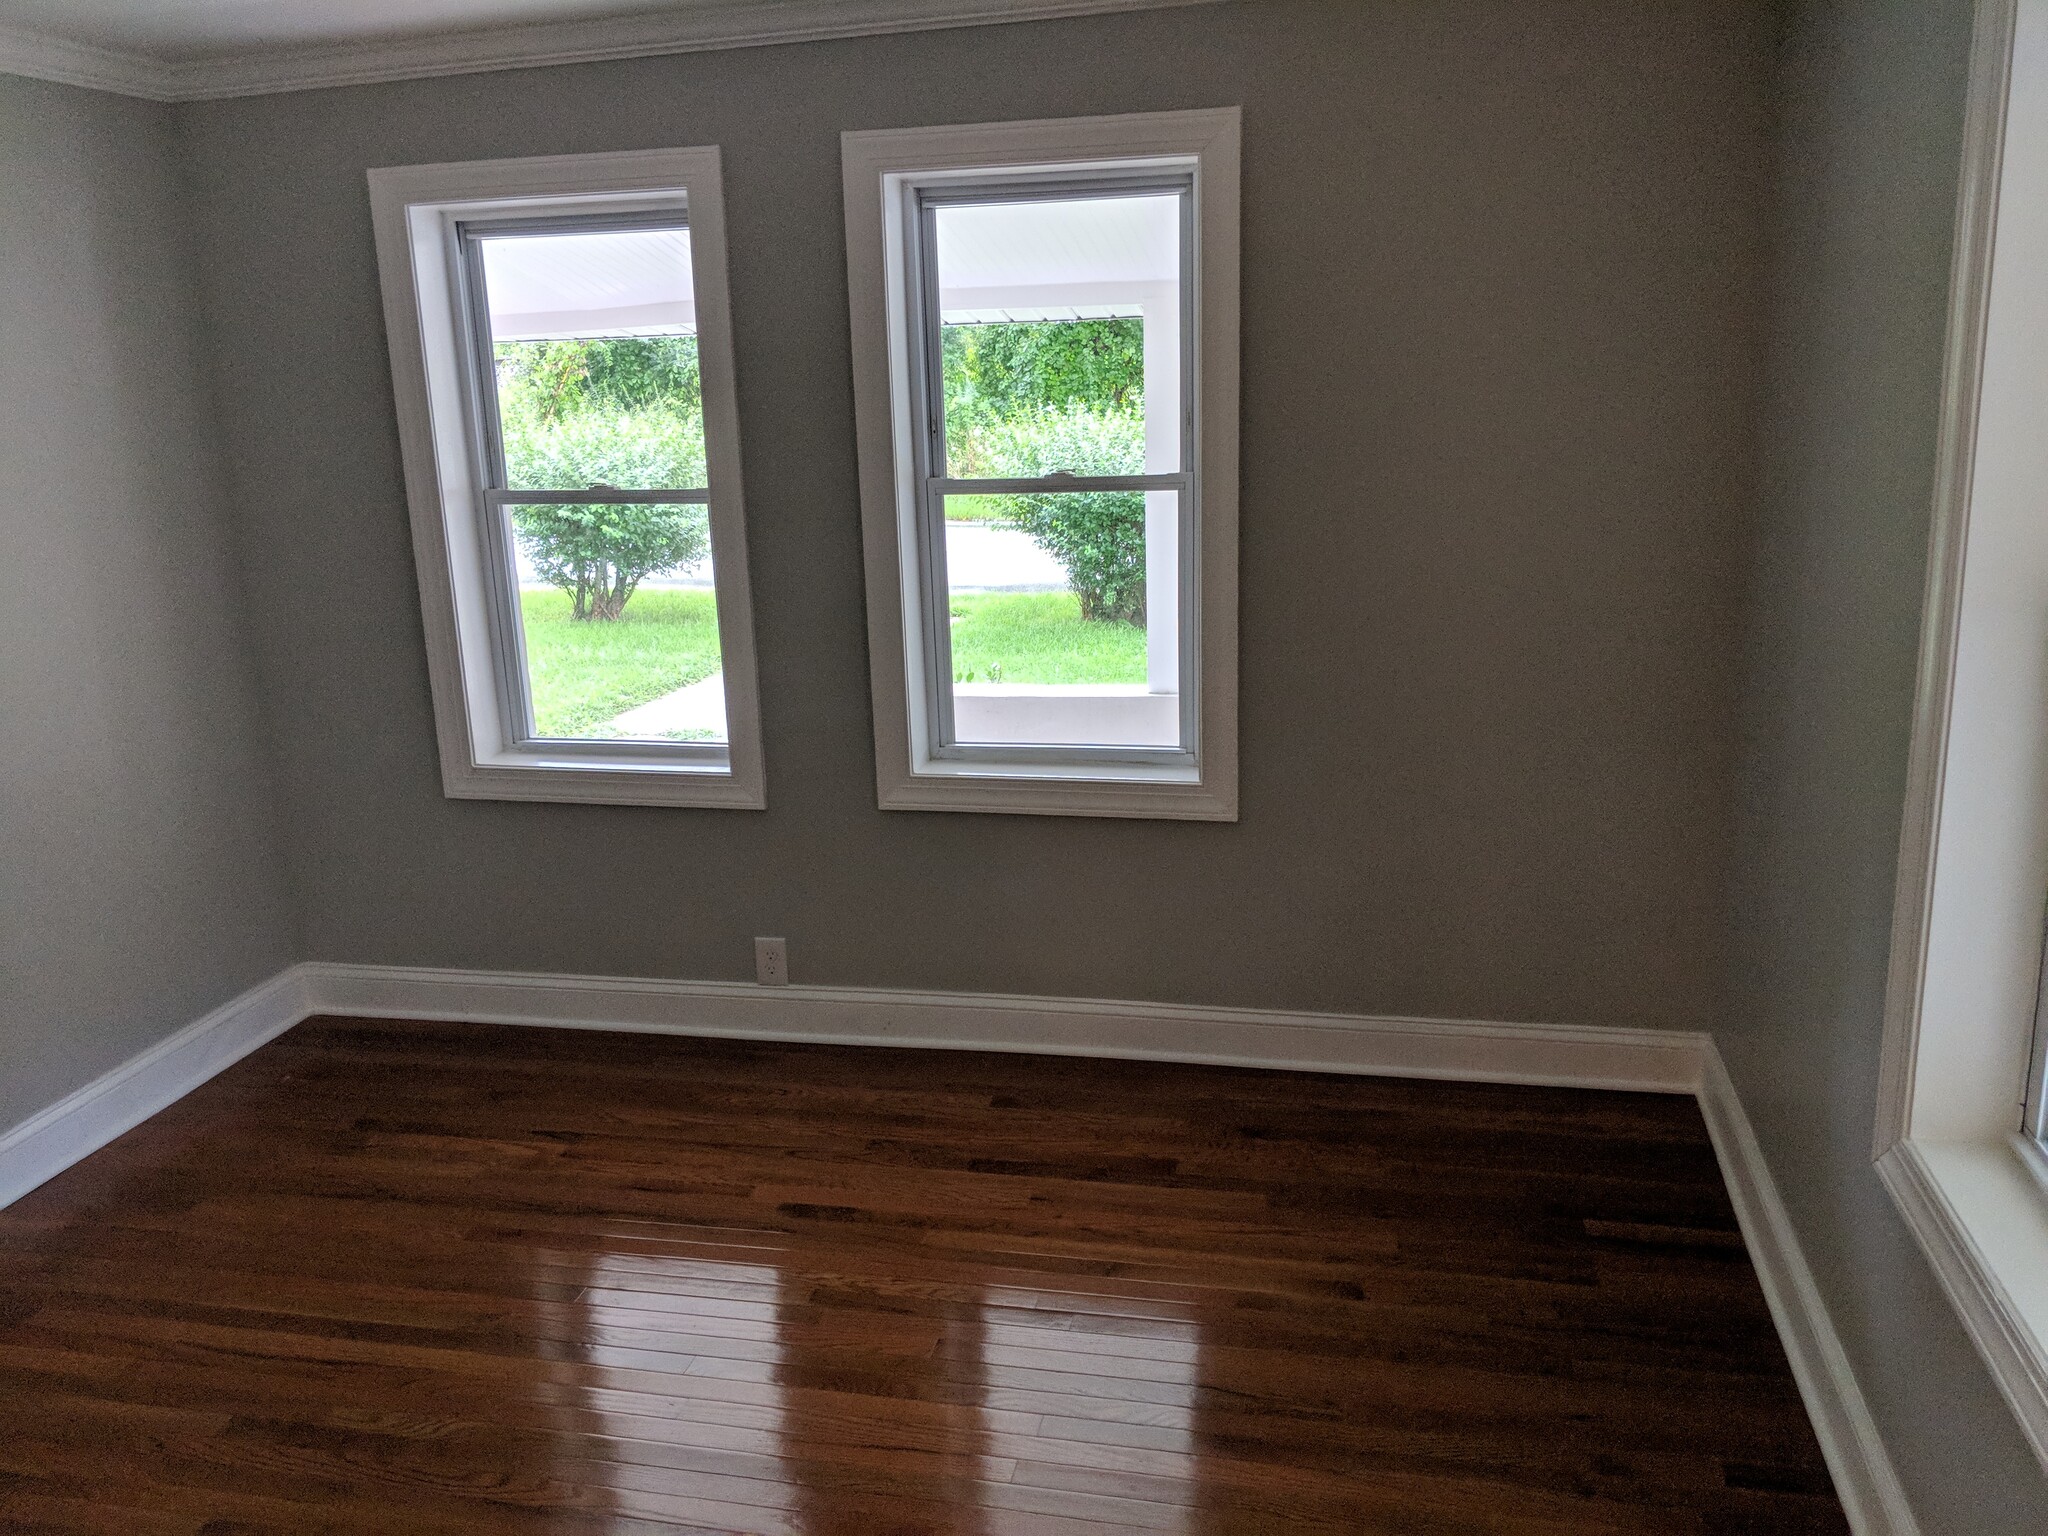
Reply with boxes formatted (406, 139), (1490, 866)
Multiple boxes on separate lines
(1878, 1141), (2048, 1452)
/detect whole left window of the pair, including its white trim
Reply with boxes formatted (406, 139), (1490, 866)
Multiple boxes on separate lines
(371, 150), (762, 807)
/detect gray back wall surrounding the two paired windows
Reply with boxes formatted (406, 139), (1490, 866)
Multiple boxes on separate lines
(184, 0), (1769, 1028)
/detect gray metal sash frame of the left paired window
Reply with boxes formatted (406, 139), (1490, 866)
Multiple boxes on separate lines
(449, 211), (731, 766)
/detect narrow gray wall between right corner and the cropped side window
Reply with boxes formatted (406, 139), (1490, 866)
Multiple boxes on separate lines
(1720, 0), (2048, 1536)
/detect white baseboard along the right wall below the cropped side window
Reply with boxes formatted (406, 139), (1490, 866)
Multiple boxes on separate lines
(1700, 1040), (1919, 1536)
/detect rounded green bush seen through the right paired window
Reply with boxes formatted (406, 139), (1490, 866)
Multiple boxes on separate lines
(973, 403), (1145, 625)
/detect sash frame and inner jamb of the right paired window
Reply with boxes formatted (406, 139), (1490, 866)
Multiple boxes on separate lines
(899, 166), (1202, 772)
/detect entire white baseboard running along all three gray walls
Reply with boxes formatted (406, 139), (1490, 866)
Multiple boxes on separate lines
(0, 963), (1919, 1536)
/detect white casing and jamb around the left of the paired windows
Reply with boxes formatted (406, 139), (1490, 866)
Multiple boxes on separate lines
(369, 147), (766, 809)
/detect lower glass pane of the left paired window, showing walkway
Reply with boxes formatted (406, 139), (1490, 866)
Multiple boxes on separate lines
(508, 502), (727, 741)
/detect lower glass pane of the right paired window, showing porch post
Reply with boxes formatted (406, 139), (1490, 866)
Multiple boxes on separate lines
(946, 492), (1180, 748)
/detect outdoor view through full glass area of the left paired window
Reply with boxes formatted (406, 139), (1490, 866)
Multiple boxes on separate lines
(463, 213), (727, 743)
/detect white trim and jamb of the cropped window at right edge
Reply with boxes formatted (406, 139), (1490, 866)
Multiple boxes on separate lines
(1874, 0), (2048, 1468)
